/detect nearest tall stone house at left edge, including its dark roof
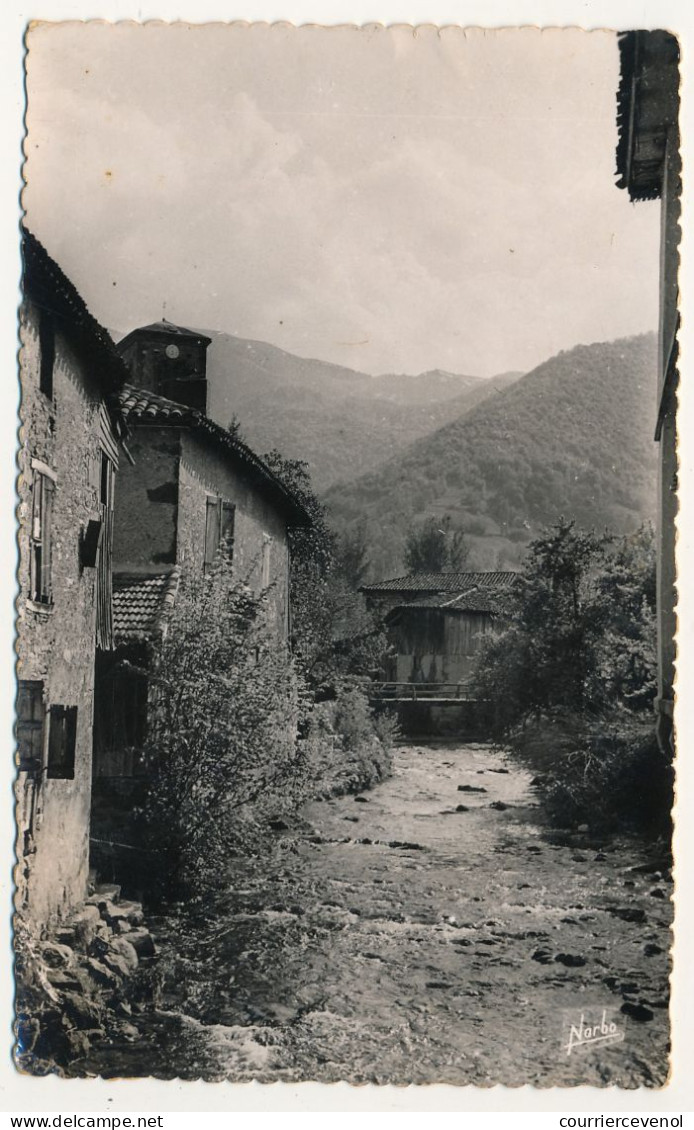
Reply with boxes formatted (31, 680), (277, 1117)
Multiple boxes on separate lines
(16, 224), (127, 924)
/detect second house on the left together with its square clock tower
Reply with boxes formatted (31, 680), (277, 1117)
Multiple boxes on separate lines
(93, 322), (311, 863)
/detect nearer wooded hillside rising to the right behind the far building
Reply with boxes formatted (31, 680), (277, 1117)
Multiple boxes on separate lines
(326, 333), (656, 576)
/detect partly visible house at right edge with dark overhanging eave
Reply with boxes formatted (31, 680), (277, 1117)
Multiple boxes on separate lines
(617, 31), (682, 754)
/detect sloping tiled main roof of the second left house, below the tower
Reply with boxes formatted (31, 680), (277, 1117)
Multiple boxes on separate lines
(119, 384), (312, 525)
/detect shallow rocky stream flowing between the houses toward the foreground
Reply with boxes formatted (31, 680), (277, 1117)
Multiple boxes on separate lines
(81, 746), (671, 1087)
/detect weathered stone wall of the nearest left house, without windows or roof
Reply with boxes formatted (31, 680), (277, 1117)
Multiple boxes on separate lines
(16, 303), (112, 922)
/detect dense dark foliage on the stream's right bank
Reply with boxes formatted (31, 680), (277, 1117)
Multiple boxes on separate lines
(476, 520), (673, 832)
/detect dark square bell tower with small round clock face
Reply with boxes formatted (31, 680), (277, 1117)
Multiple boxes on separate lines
(118, 320), (211, 414)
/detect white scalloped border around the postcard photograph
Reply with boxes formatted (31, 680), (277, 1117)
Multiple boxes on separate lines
(0, 0), (694, 1128)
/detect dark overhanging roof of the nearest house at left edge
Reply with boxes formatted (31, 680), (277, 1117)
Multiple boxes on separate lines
(21, 227), (128, 393)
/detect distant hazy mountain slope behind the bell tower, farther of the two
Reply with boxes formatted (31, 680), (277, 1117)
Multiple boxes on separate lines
(201, 331), (520, 490)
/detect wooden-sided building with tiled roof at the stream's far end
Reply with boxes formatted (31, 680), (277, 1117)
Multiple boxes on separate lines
(362, 572), (518, 698)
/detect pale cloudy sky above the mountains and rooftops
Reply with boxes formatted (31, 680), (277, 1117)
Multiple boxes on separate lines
(24, 23), (659, 375)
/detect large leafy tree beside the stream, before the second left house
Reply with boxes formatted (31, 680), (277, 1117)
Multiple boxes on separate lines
(140, 560), (305, 893)
